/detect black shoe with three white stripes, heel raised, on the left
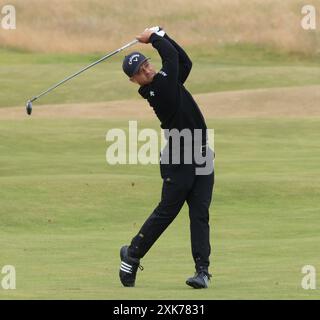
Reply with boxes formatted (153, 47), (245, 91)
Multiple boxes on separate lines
(119, 246), (143, 287)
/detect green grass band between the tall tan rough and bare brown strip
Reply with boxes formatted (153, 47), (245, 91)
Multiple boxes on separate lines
(0, 45), (320, 107)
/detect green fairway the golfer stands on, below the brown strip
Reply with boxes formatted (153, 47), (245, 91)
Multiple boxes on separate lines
(0, 117), (320, 299)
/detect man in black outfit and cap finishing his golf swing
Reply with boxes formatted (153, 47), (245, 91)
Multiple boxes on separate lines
(119, 27), (214, 289)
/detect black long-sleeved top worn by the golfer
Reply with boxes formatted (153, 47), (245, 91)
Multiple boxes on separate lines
(139, 33), (207, 143)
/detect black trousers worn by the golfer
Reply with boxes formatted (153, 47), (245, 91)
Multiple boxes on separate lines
(129, 151), (214, 270)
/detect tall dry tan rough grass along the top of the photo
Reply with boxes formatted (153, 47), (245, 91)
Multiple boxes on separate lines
(0, 0), (319, 54)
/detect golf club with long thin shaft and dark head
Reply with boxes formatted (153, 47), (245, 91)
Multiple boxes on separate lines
(26, 40), (139, 115)
